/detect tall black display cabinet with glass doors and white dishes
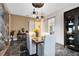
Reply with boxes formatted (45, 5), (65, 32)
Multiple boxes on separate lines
(64, 7), (79, 51)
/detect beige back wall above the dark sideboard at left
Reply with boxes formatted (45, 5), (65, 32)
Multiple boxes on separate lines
(11, 15), (29, 34)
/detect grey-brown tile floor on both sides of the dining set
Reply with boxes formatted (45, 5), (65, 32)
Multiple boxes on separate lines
(5, 42), (79, 56)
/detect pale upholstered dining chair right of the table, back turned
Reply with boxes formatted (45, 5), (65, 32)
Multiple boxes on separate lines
(38, 35), (55, 56)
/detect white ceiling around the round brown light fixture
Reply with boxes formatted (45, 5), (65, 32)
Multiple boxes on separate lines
(6, 3), (77, 17)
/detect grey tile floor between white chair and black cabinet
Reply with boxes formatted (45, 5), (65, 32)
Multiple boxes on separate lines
(55, 44), (79, 56)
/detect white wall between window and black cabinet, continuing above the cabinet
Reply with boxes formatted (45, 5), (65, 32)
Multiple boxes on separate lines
(48, 4), (79, 45)
